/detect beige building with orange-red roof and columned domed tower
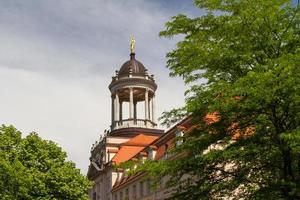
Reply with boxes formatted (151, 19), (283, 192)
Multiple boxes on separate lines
(87, 39), (195, 200)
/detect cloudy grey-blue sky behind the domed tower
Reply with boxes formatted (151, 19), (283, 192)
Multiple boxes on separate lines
(0, 0), (202, 174)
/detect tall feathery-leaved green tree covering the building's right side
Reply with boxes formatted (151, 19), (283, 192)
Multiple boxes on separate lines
(142, 0), (300, 199)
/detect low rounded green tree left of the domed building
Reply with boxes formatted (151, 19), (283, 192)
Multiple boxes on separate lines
(0, 125), (91, 200)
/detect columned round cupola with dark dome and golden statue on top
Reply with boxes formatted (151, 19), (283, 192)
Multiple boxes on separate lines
(109, 37), (157, 132)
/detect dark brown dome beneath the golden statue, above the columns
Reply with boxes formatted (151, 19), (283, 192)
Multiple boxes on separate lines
(118, 53), (147, 77)
